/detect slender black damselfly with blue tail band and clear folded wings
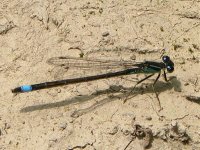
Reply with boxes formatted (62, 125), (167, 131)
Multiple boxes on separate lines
(12, 56), (174, 93)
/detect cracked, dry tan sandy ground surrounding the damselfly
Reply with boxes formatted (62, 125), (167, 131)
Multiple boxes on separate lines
(0, 0), (200, 150)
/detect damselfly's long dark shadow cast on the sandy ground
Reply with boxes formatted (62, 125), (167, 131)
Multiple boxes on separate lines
(20, 78), (181, 117)
